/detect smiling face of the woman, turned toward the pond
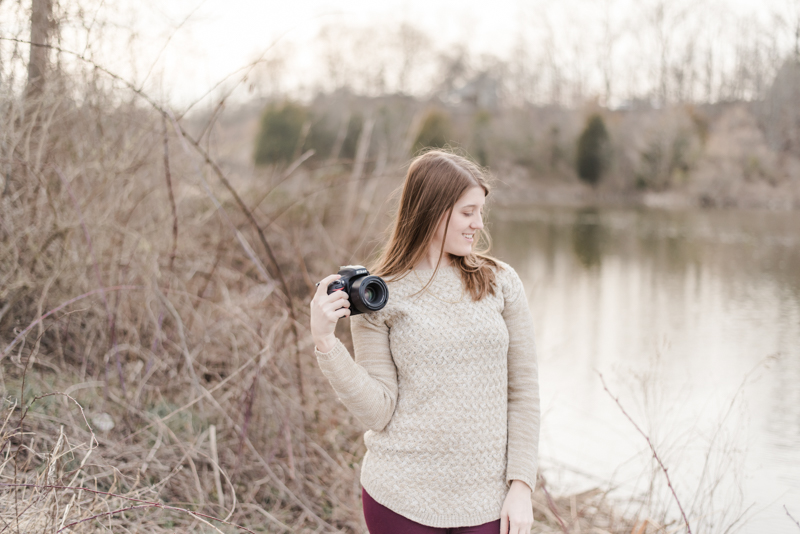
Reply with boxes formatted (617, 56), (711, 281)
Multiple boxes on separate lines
(434, 186), (486, 256)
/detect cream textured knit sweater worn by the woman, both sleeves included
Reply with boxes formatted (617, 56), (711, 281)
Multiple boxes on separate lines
(315, 262), (540, 528)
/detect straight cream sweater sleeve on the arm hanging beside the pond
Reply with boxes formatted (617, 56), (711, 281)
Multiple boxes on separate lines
(501, 264), (541, 490)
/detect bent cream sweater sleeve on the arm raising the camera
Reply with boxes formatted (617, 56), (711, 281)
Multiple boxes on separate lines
(314, 312), (397, 431)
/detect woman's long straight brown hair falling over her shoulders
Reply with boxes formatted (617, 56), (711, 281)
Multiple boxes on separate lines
(370, 150), (502, 301)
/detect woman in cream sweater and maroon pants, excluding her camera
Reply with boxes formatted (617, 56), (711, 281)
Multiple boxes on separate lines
(311, 151), (539, 534)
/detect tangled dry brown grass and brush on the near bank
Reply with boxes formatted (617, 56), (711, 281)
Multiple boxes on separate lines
(0, 36), (764, 534)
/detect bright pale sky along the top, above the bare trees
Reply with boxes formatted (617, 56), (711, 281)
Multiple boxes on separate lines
(0, 0), (800, 106)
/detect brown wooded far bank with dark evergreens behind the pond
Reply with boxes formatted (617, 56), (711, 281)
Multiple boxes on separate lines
(254, 60), (800, 208)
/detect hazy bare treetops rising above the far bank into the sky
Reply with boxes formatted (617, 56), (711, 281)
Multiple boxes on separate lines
(242, 0), (800, 108)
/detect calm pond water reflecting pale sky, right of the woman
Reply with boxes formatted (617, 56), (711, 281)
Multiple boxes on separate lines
(488, 207), (800, 534)
